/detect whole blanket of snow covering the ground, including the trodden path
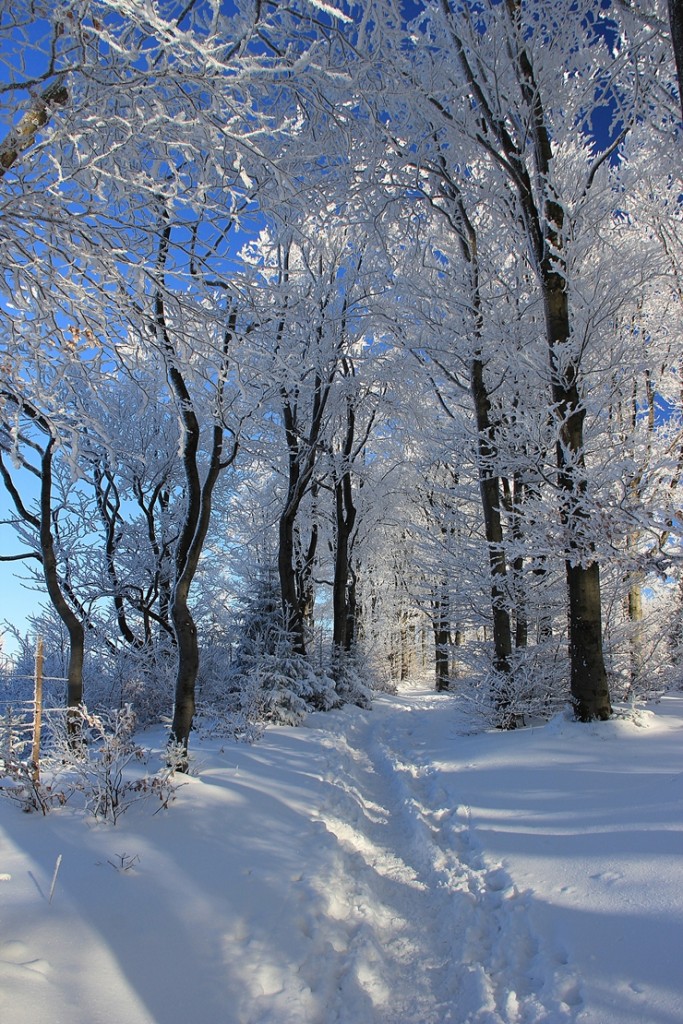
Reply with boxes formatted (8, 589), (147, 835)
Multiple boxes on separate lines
(0, 686), (683, 1024)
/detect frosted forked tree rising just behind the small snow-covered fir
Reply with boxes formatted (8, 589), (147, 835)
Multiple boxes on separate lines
(242, 223), (374, 655)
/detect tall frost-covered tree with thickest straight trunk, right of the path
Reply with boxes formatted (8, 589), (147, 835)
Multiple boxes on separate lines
(348, 0), (683, 719)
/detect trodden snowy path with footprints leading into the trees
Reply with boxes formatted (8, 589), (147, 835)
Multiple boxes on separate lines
(301, 694), (581, 1024)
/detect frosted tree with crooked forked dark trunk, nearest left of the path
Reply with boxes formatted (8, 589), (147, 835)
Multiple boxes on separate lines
(0, 0), (368, 745)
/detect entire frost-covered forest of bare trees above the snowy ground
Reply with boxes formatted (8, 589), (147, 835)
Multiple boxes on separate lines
(0, 0), (683, 751)
